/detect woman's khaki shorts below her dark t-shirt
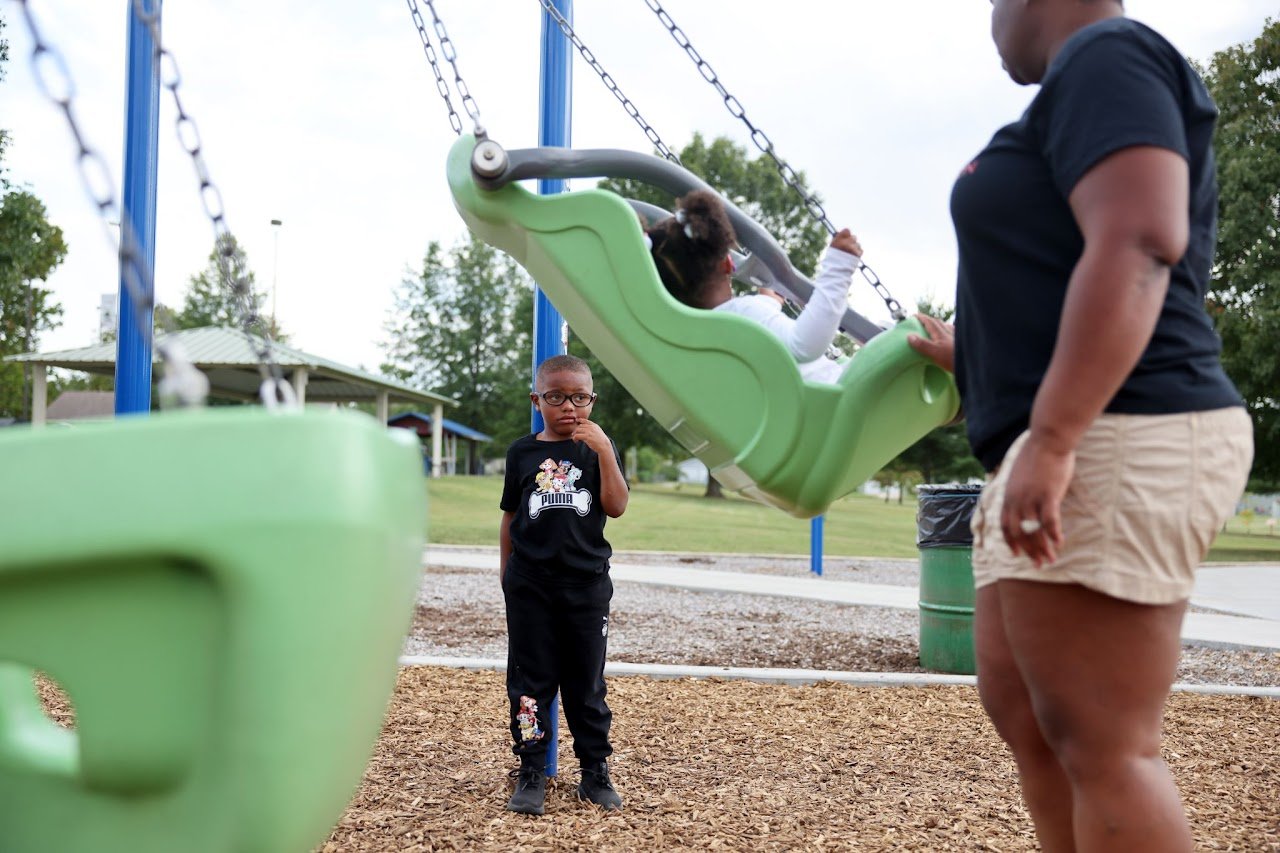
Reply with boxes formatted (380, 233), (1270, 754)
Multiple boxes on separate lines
(972, 407), (1253, 605)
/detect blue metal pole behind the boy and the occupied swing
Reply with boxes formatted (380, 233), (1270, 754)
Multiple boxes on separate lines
(532, 0), (573, 776)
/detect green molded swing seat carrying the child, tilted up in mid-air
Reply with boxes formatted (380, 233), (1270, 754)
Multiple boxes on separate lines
(448, 136), (959, 517)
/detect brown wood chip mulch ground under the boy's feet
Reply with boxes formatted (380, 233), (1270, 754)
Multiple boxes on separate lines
(320, 667), (1280, 853)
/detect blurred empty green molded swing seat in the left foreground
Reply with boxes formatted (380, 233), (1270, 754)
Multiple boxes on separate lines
(0, 407), (426, 853)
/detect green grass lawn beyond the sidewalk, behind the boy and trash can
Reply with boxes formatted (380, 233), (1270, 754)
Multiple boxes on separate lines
(428, 476), (1280, 562)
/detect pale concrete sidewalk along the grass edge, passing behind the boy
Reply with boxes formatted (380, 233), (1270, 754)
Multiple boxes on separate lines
(424, 546), (1280, 648)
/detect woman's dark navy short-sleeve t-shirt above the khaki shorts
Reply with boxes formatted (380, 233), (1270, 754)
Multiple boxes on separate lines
(951, 18), (1242, 470)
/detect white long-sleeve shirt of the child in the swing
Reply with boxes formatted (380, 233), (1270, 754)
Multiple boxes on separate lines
(714, 246), (863, 383)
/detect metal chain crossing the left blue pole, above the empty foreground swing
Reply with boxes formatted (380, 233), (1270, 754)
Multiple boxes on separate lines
(125, 0), (297, 409)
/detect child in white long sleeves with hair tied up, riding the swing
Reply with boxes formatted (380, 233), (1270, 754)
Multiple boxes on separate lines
(645, 190), (863, 384)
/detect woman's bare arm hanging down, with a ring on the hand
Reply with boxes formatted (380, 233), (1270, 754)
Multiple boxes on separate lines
(1001, 146), (1190, 565)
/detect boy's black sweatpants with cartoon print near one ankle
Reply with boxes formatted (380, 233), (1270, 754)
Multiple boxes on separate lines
(502, 565), (613, 765)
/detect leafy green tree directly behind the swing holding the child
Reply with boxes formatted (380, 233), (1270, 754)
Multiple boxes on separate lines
(591, 133), (827, 497)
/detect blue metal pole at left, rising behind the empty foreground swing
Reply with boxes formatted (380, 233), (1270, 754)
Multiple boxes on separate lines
(115, 0), (161, 415)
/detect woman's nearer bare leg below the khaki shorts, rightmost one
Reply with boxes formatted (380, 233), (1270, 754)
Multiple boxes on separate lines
(998, 567), (1192, 853)
